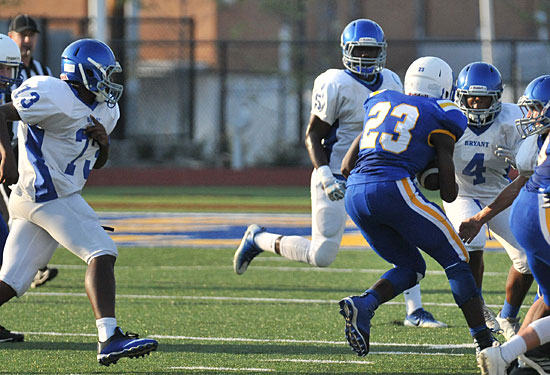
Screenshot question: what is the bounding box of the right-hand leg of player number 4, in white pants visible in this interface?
[489,209,533,340]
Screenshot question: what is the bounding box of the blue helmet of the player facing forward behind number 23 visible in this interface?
[340,19,388,77]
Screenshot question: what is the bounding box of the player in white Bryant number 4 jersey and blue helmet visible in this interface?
[443,62,533,338]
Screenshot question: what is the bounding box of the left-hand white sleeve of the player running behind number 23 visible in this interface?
[311,73,339,124]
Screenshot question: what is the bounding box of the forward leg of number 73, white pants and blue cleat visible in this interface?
[29,194,158,366]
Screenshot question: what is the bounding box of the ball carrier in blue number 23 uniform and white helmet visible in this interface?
[340,57,496,356]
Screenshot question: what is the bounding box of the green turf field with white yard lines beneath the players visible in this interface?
[0,188,534,375]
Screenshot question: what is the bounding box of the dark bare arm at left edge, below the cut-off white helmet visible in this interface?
[0,103,21,184]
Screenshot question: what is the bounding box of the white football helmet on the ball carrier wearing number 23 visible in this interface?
[405,56,454,100]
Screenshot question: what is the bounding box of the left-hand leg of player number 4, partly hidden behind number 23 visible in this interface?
[443,197,500,332]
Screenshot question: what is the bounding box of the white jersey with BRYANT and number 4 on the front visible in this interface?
[453,103,522,198]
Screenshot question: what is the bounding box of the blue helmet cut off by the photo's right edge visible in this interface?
[516,75,550,138]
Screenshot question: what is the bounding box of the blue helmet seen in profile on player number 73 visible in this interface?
[61,39,123,107]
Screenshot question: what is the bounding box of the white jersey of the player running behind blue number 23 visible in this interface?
[311,69,403,175]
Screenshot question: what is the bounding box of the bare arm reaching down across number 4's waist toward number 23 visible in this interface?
[458,175,529,244]
